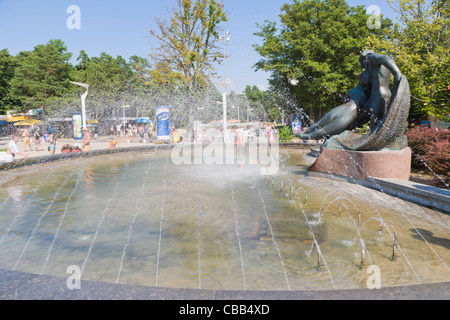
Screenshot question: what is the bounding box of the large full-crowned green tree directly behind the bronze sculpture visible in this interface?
[254,0,390,118]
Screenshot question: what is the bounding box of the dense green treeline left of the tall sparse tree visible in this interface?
[0,40,156,117]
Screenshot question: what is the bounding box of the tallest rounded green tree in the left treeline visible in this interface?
[10,40,72,111]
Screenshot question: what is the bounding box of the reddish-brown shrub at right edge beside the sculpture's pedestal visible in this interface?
[406,127,450,182]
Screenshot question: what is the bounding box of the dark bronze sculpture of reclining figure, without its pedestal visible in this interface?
[297,50,410,151]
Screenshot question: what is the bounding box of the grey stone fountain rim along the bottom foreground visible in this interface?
[0,269,450,300]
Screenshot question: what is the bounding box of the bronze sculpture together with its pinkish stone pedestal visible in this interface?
[297,50,411,180]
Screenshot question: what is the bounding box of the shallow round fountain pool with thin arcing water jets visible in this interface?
[0,67,450,299]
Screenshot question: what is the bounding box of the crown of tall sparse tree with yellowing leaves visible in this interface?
[150,0,227,92]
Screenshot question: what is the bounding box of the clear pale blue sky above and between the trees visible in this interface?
[0,0,395,93]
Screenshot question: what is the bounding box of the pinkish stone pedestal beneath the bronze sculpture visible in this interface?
[308,148,411,180]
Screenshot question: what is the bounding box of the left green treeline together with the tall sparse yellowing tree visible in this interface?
[0,0,230,121]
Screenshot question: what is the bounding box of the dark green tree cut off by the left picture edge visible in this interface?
[0,49,16,114]
